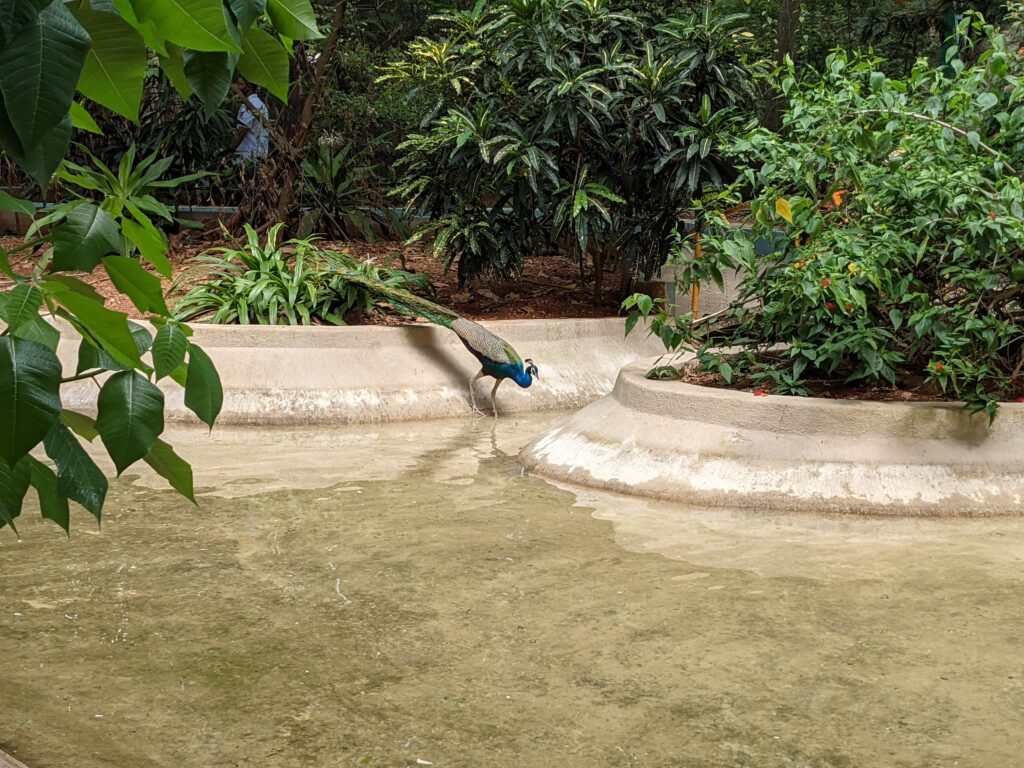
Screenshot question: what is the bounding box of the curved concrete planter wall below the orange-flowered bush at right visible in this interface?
[519,364,1024,515]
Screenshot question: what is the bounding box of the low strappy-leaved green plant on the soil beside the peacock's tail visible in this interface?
[175,224,430,326]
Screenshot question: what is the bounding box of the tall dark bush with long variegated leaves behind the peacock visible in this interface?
[384,0,751,291]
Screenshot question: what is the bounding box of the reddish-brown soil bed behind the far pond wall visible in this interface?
[0,233,620,325]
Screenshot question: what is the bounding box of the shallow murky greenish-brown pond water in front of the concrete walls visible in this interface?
[0,416,1024,768]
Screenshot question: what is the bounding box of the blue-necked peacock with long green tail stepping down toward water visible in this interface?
[344,271,541,419]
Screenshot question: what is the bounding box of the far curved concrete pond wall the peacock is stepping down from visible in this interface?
[60,317,658,425]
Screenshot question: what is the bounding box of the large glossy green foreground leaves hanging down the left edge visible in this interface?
[0,0,318,529]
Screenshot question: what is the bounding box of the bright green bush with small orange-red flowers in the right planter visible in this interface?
[631,16,1024,418]
